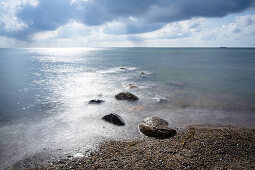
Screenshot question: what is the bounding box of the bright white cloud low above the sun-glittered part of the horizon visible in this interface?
[28,21,129,47]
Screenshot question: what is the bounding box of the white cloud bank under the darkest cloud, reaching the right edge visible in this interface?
[137,14,255,47]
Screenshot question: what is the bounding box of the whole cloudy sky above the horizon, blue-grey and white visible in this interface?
[0,0,255,47]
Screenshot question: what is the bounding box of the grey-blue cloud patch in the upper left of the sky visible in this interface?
[0,0,77,40]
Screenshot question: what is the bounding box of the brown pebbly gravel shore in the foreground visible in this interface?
[13,125,255,169]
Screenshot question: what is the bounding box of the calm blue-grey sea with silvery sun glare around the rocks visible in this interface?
[0,48,255,167]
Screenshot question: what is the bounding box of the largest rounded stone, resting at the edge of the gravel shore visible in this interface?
[139,116,176,138]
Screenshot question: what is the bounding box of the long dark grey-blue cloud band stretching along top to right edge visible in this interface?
[78,0,255,25]
